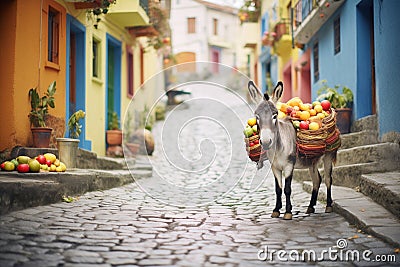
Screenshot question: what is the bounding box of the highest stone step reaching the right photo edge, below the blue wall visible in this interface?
[336,143,400,166]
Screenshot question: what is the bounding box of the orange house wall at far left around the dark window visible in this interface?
[0,0,65,152]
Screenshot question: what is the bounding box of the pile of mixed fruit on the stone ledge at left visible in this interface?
[0,153,67,173]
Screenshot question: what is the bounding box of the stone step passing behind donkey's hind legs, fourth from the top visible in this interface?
[293,162,399,188]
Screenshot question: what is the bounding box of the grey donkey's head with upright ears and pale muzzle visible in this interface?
[248,81,283,150]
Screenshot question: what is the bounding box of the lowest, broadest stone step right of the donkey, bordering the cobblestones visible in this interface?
[303,182,400,247]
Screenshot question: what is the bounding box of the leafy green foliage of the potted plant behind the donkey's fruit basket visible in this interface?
[317,80,353,108]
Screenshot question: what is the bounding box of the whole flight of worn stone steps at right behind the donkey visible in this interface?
[293,116,400,247]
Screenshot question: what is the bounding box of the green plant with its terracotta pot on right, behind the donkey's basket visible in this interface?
[317,80,353,133]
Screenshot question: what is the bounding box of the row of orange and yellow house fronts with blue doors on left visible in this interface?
[0,0,166,158]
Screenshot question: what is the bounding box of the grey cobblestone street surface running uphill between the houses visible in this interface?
[0,80,399,267]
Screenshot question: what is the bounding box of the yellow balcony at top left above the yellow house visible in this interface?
[107,0,150,27]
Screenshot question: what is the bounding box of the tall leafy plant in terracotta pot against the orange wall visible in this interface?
[28,81,56,148]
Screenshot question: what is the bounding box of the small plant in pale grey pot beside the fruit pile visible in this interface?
[56,110,85,169]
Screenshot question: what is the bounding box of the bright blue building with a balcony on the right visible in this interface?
[293,0,400,141]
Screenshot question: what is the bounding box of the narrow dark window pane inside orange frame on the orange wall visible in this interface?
[47,6,60,64]
